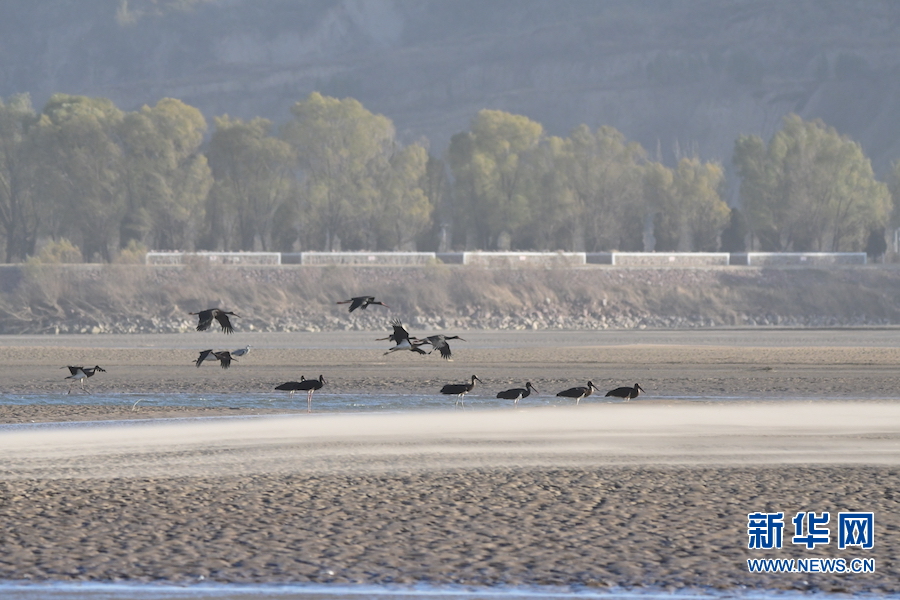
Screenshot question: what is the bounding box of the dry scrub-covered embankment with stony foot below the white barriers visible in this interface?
[0,265,900,334]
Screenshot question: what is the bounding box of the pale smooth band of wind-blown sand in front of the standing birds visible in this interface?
[0,403,900,479]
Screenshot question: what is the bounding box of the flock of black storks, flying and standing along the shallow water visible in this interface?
[62,296,646,413]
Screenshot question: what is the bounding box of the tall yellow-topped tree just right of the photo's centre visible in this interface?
[449,110,543,248]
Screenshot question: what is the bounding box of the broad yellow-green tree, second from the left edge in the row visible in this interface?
[35,94,127,261]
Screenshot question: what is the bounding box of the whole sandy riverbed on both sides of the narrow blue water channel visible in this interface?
[0,333,900,593]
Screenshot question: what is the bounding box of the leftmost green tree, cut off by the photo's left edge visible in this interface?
[0,95,39,262]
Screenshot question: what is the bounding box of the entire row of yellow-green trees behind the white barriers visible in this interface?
[0,93,900,262]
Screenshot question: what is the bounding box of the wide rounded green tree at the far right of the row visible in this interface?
[734,115,891,251]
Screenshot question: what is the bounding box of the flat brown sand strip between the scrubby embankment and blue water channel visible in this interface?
[0,329,900,409]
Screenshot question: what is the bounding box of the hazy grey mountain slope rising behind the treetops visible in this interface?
[0,0,900,174]
